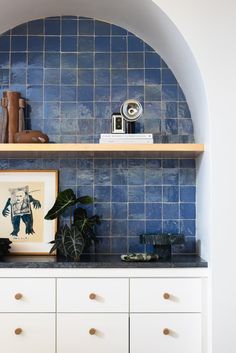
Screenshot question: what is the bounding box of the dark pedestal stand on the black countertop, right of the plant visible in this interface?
[140,233,185,260]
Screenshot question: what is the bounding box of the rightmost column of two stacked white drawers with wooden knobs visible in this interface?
[130,278,202,353]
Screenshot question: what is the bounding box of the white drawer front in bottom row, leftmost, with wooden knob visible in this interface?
[0,314,55,353]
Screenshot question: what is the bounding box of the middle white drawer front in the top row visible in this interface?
[57,278,129,312]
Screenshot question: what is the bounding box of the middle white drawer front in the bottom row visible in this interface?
[57,313,129,353]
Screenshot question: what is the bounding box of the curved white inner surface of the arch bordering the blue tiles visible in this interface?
[0,0,210,257]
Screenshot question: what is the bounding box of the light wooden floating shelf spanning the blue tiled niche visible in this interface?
[0,143,204,157]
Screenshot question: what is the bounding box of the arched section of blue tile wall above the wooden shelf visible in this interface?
[0,17,193,142]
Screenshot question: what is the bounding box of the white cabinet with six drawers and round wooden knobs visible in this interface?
[0,268,207,353]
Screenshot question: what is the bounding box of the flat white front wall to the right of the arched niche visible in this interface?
[153,4,236,353]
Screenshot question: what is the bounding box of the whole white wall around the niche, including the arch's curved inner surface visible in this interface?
[0,0,236,353]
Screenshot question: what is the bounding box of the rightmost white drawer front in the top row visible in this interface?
[130,278,202,312]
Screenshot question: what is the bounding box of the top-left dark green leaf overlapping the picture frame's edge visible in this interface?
[44,189,78,220]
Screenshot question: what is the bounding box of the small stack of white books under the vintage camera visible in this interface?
[99,134,153,144]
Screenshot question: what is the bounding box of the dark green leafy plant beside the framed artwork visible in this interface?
[44,189,101,261]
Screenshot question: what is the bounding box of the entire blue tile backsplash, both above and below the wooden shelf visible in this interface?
[0,16,196,253]
